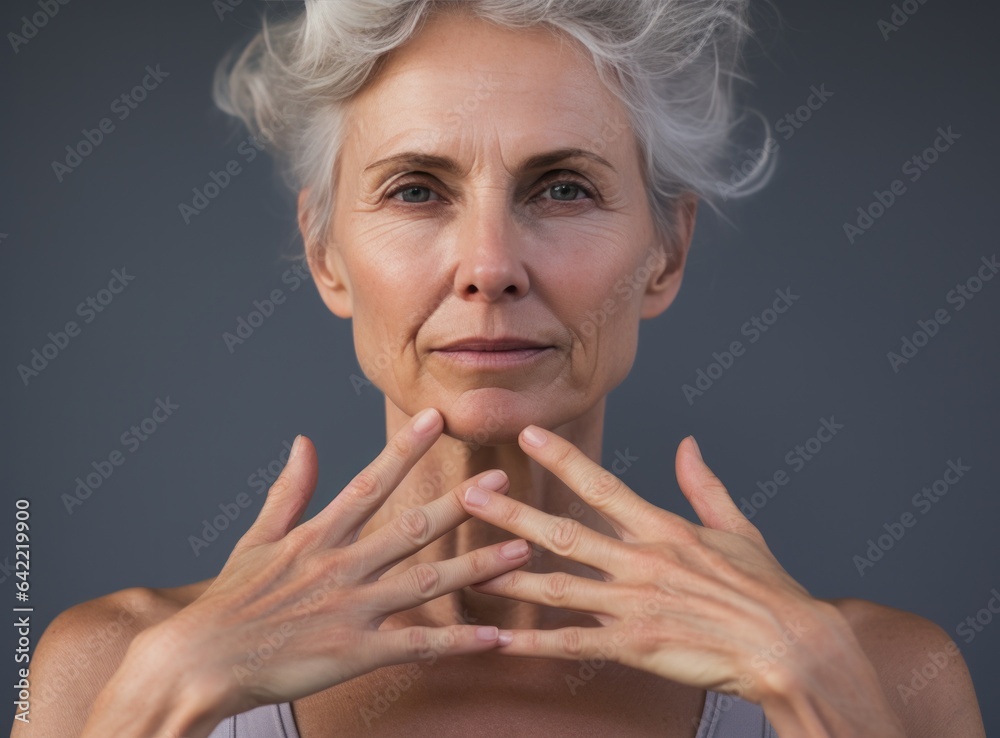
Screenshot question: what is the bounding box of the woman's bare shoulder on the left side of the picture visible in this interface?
[11,580,217,738]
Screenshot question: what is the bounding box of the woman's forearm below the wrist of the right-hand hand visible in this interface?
[761,608,906,738]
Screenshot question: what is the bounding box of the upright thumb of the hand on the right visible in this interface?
[675,436,763,540]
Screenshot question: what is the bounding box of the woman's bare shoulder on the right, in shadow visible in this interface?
[824,597,986,738]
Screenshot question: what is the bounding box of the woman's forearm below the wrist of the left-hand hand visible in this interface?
[80,620,232,738]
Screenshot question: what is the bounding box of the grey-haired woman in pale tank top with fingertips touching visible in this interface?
[14,0,984,738]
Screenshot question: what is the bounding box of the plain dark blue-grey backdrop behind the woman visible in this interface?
[0,0,1000,735]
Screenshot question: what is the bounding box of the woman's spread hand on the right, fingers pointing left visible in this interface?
[463,426,849,702]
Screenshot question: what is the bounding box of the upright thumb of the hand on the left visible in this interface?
[240,435,319,545]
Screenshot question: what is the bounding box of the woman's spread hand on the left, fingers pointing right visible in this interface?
[144,410,530,717]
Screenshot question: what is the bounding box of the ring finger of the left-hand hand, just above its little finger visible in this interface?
[365,539,531,613]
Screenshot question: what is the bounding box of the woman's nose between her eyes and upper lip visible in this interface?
[455,196,529,302]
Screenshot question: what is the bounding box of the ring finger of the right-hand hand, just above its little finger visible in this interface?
[471,569,618,615]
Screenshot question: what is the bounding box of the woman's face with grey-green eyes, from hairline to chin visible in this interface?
[313,8,693,443]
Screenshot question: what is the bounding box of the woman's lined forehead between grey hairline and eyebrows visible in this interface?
[347,11,626,162]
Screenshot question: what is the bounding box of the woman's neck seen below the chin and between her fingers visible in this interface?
[360,398,615,628]
